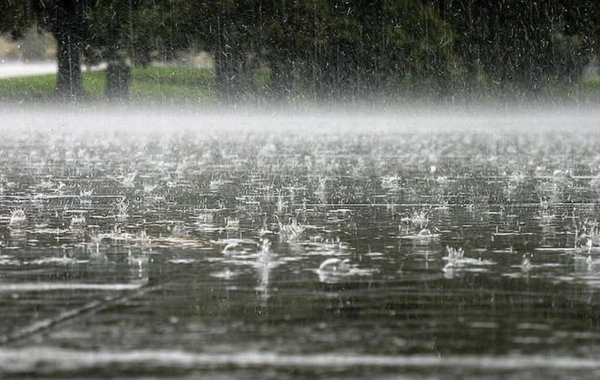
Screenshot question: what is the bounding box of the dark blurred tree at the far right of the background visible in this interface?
[444,0,600,95]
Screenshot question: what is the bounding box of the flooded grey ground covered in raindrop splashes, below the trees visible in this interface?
[0,110,600,379]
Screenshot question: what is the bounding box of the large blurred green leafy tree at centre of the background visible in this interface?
[227,0,452,100]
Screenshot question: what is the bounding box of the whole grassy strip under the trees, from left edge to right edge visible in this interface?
[0,66,600,106]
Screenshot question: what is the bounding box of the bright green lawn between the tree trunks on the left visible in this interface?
[0,66,217,102]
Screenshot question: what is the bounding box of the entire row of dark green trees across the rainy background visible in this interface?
[0,0,600,101]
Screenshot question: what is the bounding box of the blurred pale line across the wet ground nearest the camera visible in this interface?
[0,347,600,374]
